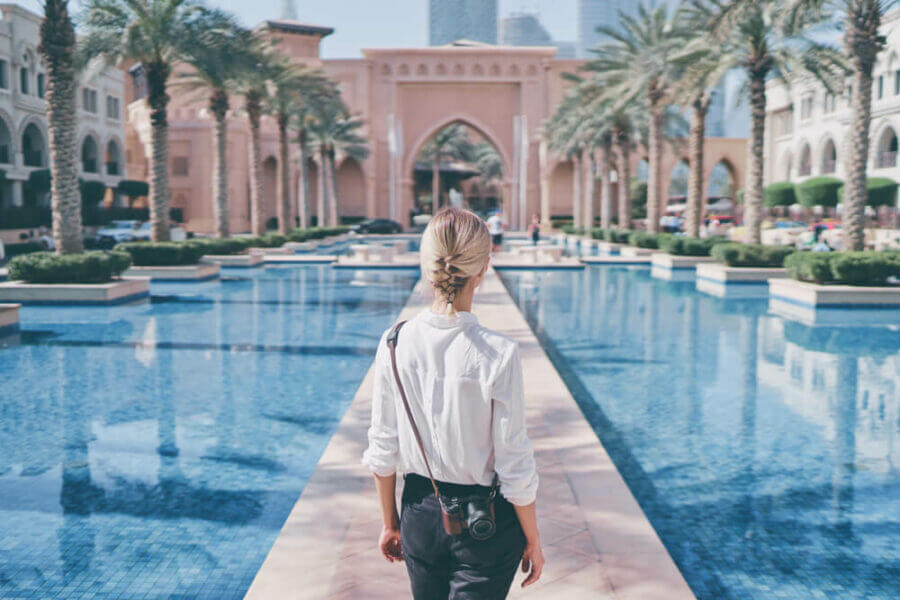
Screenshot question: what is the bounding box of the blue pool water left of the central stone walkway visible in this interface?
[0,266,417,600]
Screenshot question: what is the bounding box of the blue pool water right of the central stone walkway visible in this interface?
[502,266,900,600]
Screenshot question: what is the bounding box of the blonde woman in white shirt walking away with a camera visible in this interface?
[363,208,544,600]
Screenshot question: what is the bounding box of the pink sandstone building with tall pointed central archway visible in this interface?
[127,20,746,233]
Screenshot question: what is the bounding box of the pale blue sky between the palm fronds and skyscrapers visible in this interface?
[16,0,575,58]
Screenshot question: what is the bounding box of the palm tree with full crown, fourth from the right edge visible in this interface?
[586,3,688,232]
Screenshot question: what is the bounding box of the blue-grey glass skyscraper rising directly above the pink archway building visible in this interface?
[428,0,497,46]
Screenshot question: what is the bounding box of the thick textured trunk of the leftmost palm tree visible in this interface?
[40,0,84,254]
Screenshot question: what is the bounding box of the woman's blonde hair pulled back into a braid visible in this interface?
[419,207,491,315]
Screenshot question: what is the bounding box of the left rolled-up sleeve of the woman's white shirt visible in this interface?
[362,334,400,477]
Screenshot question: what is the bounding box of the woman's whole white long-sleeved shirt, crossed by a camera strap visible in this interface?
[363,310,538,506]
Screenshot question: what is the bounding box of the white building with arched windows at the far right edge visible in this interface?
[764,11,900,184]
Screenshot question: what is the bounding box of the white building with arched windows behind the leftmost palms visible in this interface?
[0,4,125,212]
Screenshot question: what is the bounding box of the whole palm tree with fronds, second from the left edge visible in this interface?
[81,0,201,241]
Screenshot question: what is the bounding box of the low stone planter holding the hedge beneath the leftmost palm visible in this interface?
[0,277,150,306]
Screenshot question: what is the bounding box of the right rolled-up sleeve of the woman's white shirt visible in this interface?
[492,345,538,506]
